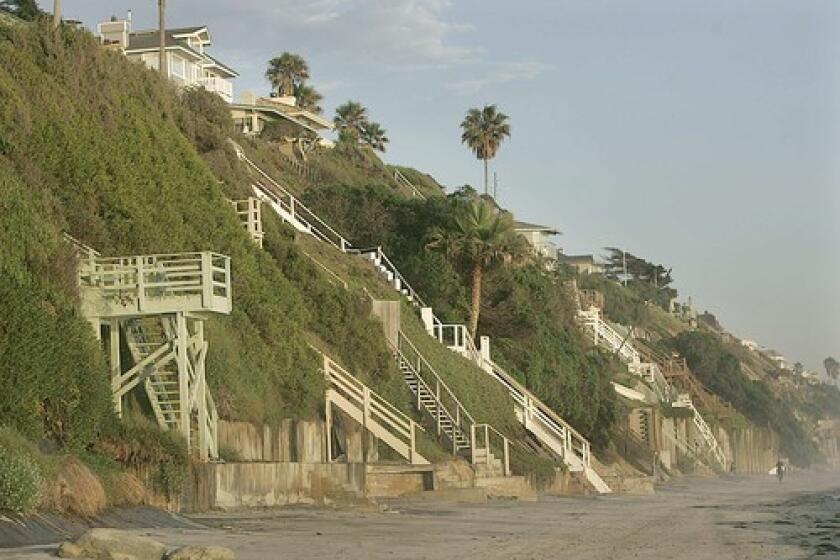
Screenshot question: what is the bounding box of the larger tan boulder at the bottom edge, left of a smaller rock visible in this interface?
[58,529,166,560]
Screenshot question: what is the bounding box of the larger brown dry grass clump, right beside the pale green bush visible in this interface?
[41,456,108,518]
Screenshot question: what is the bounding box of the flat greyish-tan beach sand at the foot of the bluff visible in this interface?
[0,473,840,560]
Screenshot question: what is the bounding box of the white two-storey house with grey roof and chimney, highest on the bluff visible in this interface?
[97,16,239,103]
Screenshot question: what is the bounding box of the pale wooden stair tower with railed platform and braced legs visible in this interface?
[74,246,226,460]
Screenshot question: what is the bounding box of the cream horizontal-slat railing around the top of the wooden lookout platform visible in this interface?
[79,251,231,313]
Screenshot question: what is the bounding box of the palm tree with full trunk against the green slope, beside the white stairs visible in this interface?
[428,199,522,337]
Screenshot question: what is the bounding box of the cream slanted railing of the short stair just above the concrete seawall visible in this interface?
[323,356,428,465]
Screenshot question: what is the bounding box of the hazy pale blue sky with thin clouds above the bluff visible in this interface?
[69,0,840,371]
